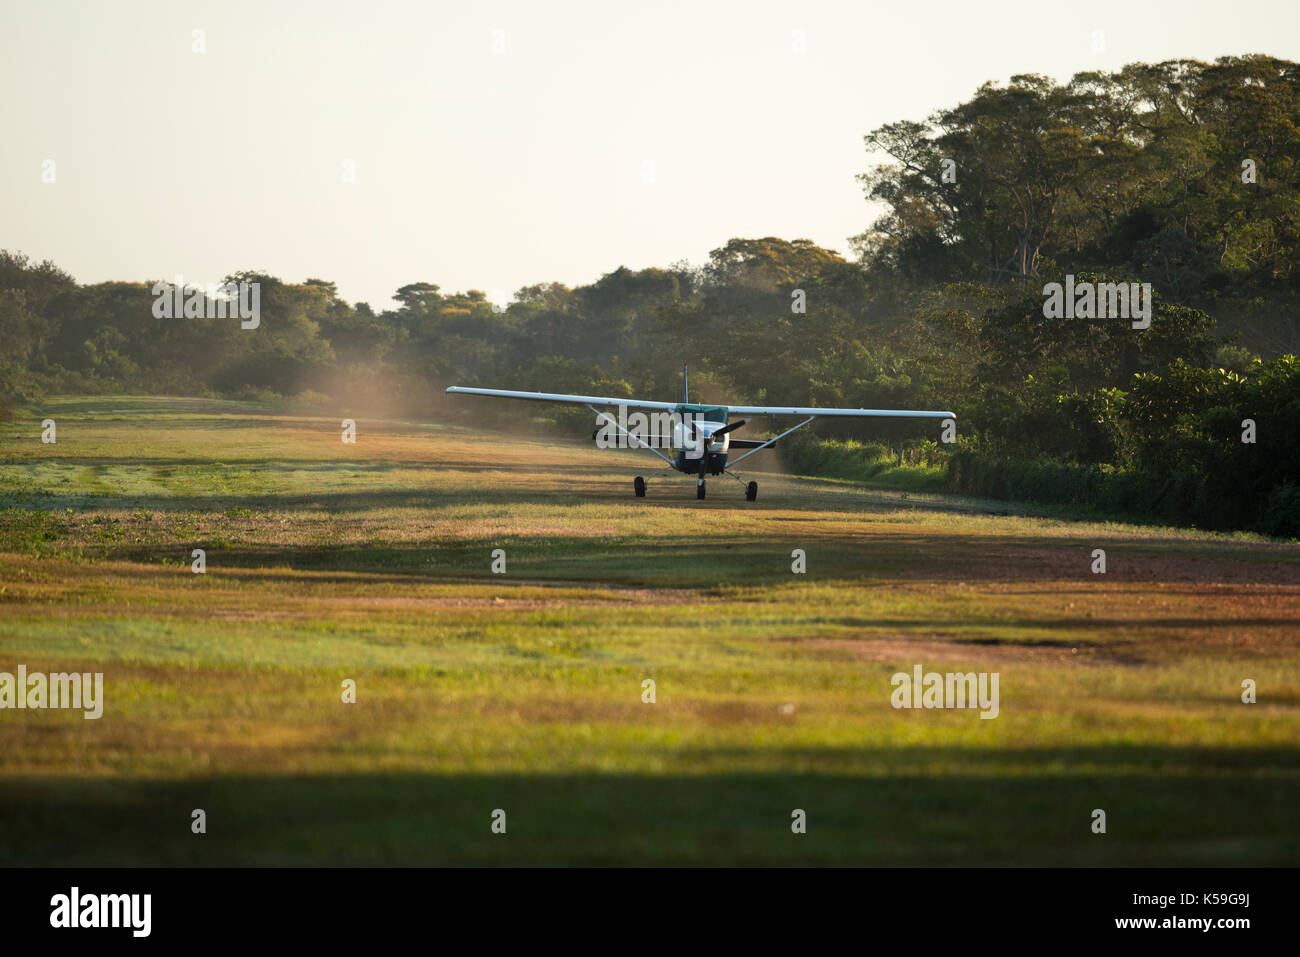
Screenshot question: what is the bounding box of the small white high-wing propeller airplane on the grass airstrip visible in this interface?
[447,365,957,502]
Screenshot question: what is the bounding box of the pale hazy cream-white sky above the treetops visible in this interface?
[0,0,1300,307]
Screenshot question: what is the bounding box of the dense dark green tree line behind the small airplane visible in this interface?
[0,56,1300,536]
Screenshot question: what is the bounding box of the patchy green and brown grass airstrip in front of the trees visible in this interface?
[0,397,1300,865]
